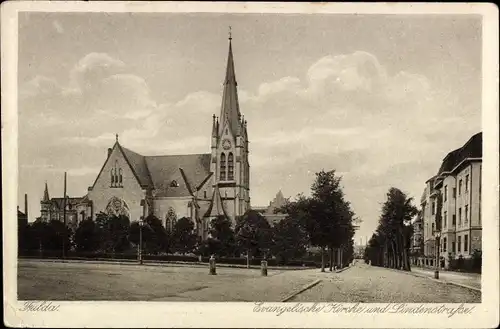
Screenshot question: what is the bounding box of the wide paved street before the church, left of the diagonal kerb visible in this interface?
[18,259,316,302]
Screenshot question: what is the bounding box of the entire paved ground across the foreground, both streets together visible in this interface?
[18,260,481,303]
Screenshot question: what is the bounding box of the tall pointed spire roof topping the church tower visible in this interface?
[219,30,240,136]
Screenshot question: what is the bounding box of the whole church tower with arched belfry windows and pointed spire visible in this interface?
[211,32,250,221]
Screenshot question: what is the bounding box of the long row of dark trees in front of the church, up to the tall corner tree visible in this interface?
[19,171,358,270]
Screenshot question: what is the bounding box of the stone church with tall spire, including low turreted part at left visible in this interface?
[41,36,250,239]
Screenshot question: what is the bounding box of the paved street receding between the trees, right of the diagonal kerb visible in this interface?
[291,263,481,303]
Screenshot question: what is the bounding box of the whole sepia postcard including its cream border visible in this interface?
[2,3,499,327]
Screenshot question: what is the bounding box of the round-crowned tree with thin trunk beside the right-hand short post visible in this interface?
[235,210,271,266]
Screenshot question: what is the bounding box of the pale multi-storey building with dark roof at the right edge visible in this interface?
[422,133,482,267]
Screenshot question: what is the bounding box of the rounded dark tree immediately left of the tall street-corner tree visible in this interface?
[271,217,308,264]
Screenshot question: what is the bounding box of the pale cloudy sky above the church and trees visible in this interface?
[18,12,482,243]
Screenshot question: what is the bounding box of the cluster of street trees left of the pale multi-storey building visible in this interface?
[364,188,418,271]
